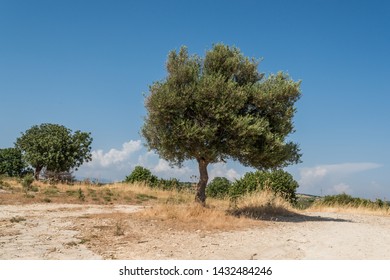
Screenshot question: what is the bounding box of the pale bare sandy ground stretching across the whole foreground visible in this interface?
[0,204,390,260]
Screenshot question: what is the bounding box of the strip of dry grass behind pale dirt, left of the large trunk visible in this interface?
[0,179,190,205]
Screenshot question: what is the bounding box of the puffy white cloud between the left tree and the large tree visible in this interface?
[90,140,142,167]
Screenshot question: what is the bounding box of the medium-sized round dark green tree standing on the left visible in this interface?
[15,123,92,179]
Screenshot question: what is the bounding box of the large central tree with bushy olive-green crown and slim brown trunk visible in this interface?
[142,44,301,204]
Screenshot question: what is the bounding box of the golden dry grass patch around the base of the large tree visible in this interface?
[134,188,296,231]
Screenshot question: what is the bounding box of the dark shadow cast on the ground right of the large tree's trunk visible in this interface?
[228,205,353,223]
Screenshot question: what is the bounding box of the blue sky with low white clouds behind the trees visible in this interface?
[0,0,390,199]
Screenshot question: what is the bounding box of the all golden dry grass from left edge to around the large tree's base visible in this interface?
[0,178,291,231]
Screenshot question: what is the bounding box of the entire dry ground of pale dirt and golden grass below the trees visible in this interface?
[0,178,390,260]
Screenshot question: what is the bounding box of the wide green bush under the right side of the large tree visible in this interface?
[229,169,299,203]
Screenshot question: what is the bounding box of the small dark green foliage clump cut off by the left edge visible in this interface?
[0,148,27,177]
